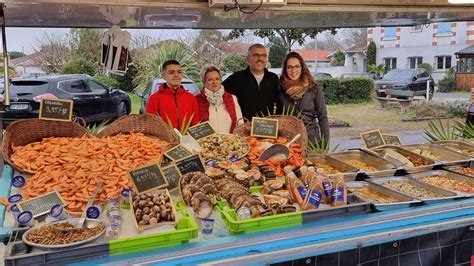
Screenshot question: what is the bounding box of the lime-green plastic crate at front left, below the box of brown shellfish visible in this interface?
[109,208,198,256]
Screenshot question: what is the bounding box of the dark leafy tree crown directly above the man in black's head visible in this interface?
[228,28,336,51]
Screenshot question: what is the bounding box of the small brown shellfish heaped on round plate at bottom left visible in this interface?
[26,222,104,245]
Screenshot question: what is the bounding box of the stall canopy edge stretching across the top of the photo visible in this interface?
[0,0,474,29]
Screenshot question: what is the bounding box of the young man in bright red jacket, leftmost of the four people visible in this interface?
[146,60,199,130]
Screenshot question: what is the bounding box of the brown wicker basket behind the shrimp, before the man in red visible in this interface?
[97,114,179,144]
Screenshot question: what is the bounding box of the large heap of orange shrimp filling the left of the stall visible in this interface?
[11,132,168,215]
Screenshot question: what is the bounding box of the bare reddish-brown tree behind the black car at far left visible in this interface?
[34,32,70,73]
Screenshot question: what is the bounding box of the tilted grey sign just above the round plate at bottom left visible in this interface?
[17,191,64,217]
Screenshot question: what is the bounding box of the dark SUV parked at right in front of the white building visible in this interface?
[375,68,434,99]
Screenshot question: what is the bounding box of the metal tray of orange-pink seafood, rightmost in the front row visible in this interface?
[408,170,474,197]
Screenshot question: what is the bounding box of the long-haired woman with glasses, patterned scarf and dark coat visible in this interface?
[279,52,329,144]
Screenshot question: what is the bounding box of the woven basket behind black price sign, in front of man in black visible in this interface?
[234,115,308,159]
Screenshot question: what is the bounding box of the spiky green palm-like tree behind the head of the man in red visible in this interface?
[133,40,200,89]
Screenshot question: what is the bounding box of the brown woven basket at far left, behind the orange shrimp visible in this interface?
[2,118,88,170]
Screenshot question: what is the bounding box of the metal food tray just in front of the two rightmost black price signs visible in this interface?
[373,145,440,173]
